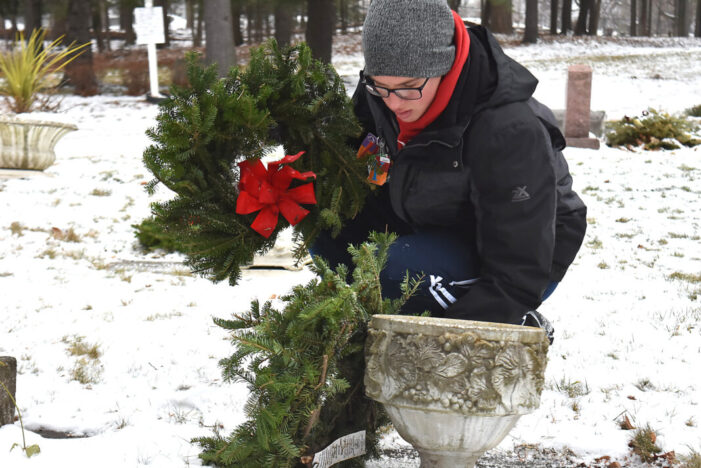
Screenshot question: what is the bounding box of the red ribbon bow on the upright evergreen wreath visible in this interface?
[236,151,316,239]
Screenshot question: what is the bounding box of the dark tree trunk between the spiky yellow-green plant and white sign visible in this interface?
[64,0,97,96]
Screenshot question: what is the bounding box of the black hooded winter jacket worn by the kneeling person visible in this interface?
[353,27,586,323]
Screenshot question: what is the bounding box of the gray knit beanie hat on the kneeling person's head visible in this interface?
[363,0,455,78]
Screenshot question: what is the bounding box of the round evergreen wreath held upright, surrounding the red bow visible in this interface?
[144,41,371,286]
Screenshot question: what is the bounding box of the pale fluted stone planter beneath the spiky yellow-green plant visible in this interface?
[0,117,78,171]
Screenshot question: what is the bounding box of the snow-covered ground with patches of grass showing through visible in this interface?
[0,33,701,468]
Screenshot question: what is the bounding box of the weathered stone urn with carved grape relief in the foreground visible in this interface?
[365,315,548,468]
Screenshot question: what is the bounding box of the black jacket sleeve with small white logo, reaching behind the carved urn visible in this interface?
[446,104,557,323]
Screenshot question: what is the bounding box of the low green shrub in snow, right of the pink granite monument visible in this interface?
[606,109,701,150]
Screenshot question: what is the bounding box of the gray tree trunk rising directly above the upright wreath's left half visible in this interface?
[204,0,236,76]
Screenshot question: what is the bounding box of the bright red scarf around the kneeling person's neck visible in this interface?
[397,11,470,149]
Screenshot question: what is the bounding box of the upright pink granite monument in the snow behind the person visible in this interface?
[565,65,599,149]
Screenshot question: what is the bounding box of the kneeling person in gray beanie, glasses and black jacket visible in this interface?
[311,0,586,340]
